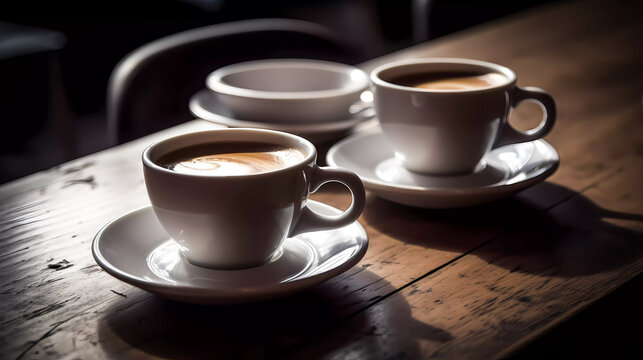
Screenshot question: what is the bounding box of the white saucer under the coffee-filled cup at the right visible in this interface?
[327,131,560,208]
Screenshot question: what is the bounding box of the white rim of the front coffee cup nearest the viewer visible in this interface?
[142,128,317,179]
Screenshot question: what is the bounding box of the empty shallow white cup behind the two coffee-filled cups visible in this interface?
[206,59,369,123]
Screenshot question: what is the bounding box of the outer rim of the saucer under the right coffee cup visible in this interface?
[326,129,560,197]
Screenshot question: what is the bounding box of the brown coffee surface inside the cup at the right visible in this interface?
[391,72,507,90]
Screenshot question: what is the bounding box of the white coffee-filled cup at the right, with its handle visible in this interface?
[371,58,556,175]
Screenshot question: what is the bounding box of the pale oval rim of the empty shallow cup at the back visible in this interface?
[206,59,369,100]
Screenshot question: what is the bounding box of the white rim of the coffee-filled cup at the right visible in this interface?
[370,57,517,94]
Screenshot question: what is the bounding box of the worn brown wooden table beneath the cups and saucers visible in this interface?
[0,1,643,359]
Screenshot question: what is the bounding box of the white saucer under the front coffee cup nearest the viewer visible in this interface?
[92,200,368,304]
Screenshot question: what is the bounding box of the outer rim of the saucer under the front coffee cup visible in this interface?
[92,199,369,303]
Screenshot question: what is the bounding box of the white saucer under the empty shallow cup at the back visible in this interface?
[189,89,375,142]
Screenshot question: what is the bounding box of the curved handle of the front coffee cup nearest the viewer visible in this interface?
[288,165,366,237]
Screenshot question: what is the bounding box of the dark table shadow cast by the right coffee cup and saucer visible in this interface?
[364,183,643,277]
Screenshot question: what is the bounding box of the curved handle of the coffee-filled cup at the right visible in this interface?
[493,87,556,148]
